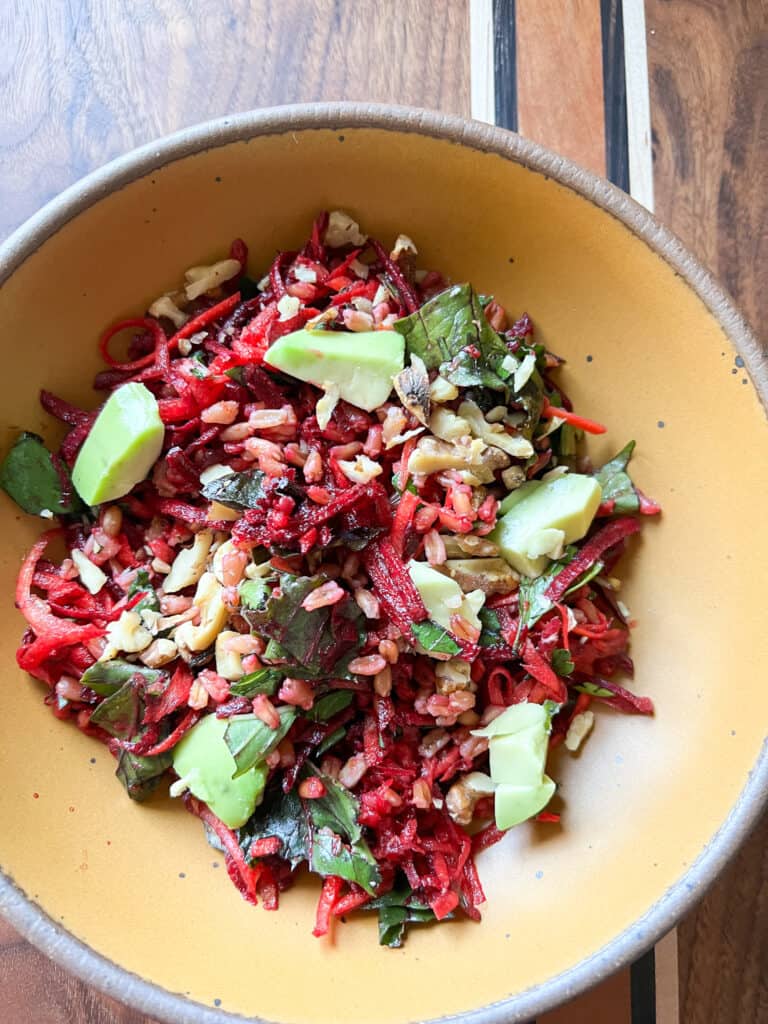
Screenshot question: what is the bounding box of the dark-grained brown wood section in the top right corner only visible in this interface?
[646,0,768,332]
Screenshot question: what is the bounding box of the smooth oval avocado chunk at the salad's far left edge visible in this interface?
[72,384,165,505]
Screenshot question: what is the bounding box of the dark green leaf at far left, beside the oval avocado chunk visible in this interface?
[0,431,83,515]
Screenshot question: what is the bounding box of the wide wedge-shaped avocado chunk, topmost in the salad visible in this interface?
[265,328,406,413]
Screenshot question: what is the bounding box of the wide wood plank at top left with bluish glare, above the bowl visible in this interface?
[0,0,469,238]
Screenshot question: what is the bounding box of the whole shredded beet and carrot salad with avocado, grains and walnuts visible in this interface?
[0,211,658,946]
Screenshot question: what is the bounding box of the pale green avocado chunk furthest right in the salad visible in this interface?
[488,473,602,577]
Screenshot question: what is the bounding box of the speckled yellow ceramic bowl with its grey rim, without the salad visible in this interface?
[0,105,768,1024]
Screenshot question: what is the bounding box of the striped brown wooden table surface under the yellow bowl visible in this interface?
[0,0,768,1024]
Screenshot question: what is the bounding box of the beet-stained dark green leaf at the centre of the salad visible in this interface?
[246,575,365,679]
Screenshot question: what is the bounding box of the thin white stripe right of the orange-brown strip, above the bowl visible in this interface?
[622,0,653,211]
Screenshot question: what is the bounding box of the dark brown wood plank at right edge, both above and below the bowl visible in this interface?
[646,0,768,1024]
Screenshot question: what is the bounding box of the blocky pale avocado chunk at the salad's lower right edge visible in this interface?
[472,701,557,830]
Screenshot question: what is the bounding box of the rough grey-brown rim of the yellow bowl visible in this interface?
[0,102,768,1024]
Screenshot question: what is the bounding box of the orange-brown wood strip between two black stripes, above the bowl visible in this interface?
[515,0,605,174]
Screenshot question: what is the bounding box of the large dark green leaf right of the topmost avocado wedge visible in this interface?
[394,285,510,391]
